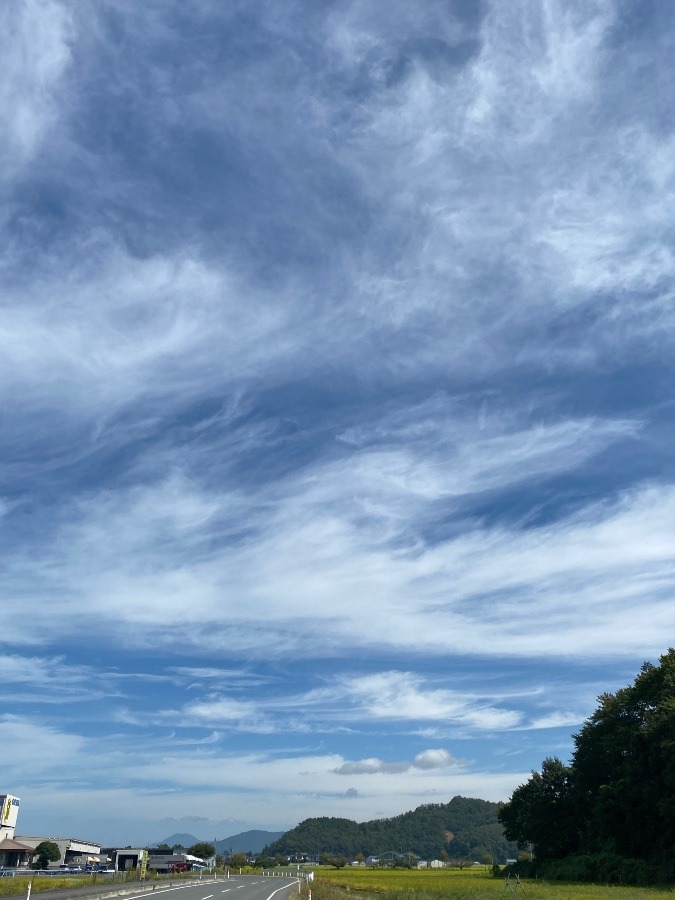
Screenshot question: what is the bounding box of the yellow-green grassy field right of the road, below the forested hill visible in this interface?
[309,867,675,900]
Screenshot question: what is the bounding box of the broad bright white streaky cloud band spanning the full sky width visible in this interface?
[5,408,675,660]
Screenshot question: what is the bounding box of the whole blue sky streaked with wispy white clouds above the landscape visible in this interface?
[0,0,675,844]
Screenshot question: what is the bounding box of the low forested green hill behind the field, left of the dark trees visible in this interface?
[265,797,516,862]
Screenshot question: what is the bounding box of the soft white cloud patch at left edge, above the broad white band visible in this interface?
[0,251,284,416]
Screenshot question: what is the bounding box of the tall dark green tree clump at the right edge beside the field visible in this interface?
[498,648,675,884]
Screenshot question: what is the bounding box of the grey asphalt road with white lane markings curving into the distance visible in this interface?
[31,875,298,900]
